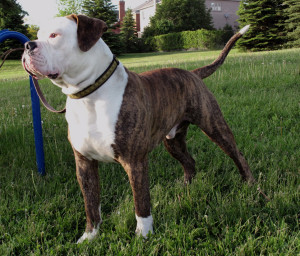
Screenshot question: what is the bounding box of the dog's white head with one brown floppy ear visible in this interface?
[22,14,107,81]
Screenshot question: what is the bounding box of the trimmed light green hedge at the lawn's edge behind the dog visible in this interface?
[152,29,224,51]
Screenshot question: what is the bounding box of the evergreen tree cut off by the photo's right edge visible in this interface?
[284,0,300,47]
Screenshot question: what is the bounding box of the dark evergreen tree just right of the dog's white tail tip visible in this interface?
[237,0,286,51]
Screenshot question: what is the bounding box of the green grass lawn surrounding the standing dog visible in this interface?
[0,49,300,255]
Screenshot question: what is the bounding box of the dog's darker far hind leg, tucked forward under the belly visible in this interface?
[164,122,196,183]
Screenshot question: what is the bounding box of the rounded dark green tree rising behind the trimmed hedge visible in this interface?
[145,0,212,36]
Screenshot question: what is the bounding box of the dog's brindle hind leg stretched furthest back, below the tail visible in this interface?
[198,98,255,183]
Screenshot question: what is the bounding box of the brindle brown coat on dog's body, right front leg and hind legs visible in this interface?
[112,68,254,217]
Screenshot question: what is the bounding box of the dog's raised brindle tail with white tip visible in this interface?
[192,25,250,79]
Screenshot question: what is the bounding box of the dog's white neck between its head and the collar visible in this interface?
[51,39,113,95]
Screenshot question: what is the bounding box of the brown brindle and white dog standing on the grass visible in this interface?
[22,14,255,243]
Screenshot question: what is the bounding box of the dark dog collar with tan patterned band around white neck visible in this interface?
[68,56,120,99]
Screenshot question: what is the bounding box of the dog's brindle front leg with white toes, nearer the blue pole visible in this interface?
[73,149,102,243]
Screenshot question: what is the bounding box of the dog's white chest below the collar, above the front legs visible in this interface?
[66,69,127,162]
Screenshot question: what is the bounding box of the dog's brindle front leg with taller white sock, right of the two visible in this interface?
[122,160,153,238]
